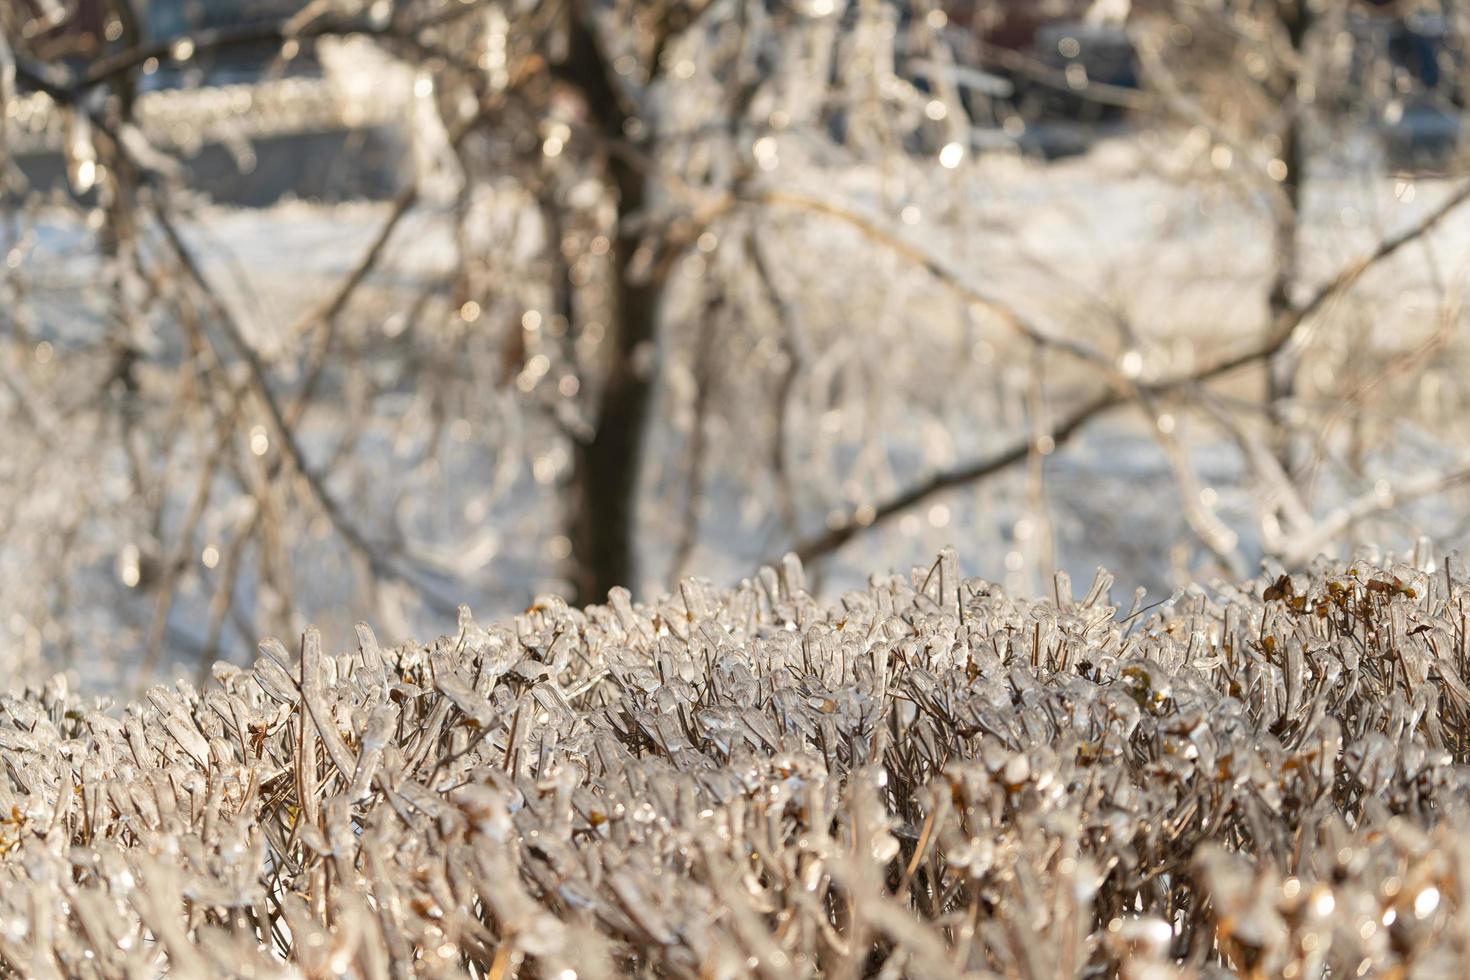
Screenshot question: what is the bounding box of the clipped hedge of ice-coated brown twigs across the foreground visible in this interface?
[0,554,1470,980]
